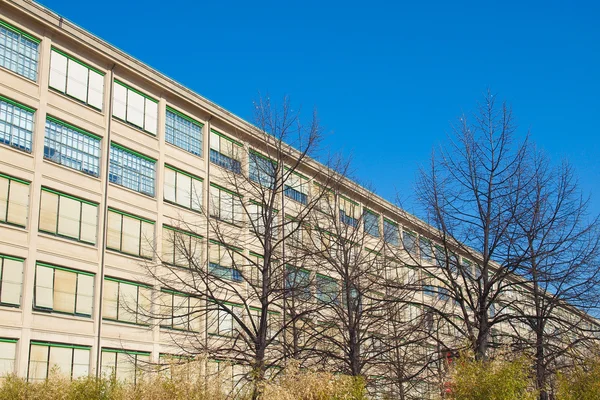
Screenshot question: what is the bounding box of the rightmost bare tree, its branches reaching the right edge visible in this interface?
[504,151,600,400]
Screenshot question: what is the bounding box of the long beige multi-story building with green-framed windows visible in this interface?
[0,0,596,396]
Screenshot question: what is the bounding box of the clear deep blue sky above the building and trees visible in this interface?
[42,0,600,219]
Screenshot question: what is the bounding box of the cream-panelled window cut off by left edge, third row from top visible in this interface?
[0,174,29,228]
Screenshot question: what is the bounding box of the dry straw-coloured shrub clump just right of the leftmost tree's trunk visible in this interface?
[261,363,366,400]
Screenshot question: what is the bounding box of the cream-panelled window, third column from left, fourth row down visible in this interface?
[102,277,152,325]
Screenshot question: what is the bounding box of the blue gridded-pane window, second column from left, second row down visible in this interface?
[44,117,101,177]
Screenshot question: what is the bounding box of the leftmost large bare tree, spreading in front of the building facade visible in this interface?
[142,98,343,398]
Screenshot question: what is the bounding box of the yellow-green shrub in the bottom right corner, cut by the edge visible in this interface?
[556,359,600,400]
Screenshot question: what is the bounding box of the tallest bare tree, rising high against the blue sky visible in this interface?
[417,93,529,359]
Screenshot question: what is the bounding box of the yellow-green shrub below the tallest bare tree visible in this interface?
[448,354,538,400]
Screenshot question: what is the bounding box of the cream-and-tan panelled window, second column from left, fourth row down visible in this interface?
[33,262,94,317]
